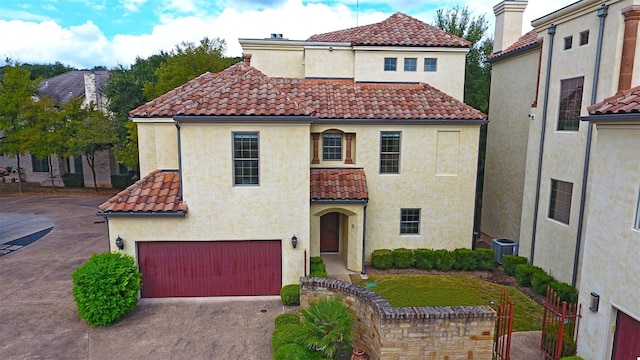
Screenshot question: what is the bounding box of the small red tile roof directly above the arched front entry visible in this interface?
[310,168,369,201]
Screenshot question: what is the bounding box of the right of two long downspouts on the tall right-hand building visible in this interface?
[571,4,609,287]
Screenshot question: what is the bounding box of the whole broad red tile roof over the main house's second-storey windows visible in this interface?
[129,63,486,120]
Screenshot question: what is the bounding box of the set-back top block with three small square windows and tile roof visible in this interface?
[239,12,471,100]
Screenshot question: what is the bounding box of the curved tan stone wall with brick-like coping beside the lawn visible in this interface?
[300,277,496,360]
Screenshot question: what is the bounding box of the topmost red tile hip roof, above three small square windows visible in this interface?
[307,12,471,47]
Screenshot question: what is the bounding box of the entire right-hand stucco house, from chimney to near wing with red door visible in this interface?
[482,0,640,359]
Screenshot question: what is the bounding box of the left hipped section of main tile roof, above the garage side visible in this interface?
[129,62,313,117]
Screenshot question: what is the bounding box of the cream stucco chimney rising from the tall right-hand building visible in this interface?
[493,0,528,53]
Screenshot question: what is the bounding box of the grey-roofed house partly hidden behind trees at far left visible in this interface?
[0,70,127,187]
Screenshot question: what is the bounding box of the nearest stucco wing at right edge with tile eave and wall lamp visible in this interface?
[578,87,640,360]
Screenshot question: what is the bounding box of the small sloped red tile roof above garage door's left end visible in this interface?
[98,170,187,216]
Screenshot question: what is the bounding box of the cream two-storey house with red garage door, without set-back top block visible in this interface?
[98,12,486,297]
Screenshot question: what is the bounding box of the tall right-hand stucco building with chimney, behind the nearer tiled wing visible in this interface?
[482,0,640,288]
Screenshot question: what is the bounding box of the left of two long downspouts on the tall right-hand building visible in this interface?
[529,24,556,264]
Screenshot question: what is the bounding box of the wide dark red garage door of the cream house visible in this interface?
[138,240,282,298]
